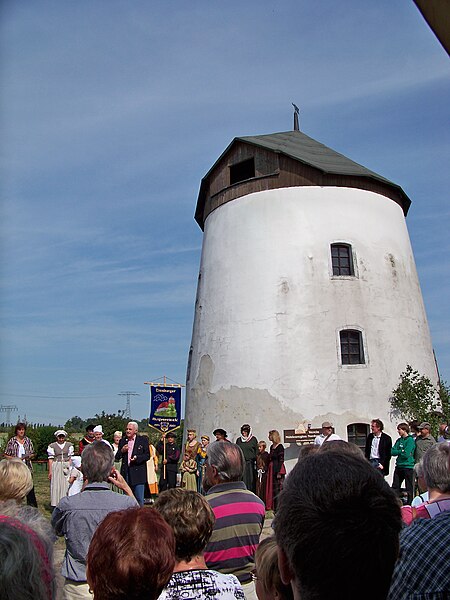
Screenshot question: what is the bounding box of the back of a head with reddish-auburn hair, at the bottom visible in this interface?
[86,508,175,600]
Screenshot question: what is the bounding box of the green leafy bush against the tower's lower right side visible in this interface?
[390,365,442,432]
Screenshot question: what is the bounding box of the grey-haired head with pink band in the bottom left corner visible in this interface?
[0,501,56,600]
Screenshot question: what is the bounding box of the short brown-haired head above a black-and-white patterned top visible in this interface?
[154,488,215,562]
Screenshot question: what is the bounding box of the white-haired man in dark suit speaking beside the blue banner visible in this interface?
[116,421,150,506]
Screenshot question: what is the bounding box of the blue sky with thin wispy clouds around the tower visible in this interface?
[0,0,450,424]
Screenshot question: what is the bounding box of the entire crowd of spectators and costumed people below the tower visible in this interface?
[0,419,450,600]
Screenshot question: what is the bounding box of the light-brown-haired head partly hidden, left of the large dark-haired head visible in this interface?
[255,536,293,600]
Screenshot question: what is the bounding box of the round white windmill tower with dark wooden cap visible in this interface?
[186,126,437,458]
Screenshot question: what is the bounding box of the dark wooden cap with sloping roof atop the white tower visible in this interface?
[195,131,411,230]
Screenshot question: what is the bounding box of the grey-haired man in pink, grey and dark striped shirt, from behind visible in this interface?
[203,442,265,599]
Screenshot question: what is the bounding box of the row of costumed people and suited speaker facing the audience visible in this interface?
[37,421,286,510]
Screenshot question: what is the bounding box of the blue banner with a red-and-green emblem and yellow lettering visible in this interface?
[148,385,181,432]
